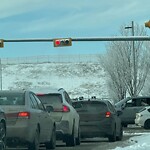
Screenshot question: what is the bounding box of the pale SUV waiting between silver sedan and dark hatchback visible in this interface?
[32,88,80,146]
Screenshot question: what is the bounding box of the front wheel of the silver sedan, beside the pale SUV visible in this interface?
[45,127,56,150]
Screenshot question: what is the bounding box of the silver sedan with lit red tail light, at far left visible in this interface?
[0,90,56,150]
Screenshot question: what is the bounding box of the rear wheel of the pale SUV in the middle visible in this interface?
[66,127,76,146]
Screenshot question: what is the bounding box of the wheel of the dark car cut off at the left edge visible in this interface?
[0,122,6,150]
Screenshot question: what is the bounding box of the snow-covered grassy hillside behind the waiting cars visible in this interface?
[2,63,109,98]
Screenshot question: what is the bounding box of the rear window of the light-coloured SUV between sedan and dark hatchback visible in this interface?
[37,94,62,105]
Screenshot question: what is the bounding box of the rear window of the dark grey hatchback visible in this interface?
[74,102,107,113]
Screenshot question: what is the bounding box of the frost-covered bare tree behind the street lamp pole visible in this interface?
[101,24,150,99]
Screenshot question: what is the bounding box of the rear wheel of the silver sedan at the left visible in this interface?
[28,129,40,150]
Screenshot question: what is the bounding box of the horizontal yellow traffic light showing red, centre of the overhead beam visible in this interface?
[53,38,72,47]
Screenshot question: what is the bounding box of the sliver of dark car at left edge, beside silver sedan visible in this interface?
[0,108,6,150]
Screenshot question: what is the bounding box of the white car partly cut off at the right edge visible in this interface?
[135,106,150,129]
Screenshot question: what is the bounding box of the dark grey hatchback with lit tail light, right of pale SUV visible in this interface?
[73,99,123,142]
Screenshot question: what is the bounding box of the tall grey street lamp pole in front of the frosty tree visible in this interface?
[125,21,137,96]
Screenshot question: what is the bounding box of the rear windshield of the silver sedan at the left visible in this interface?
[0,93,25,105]
